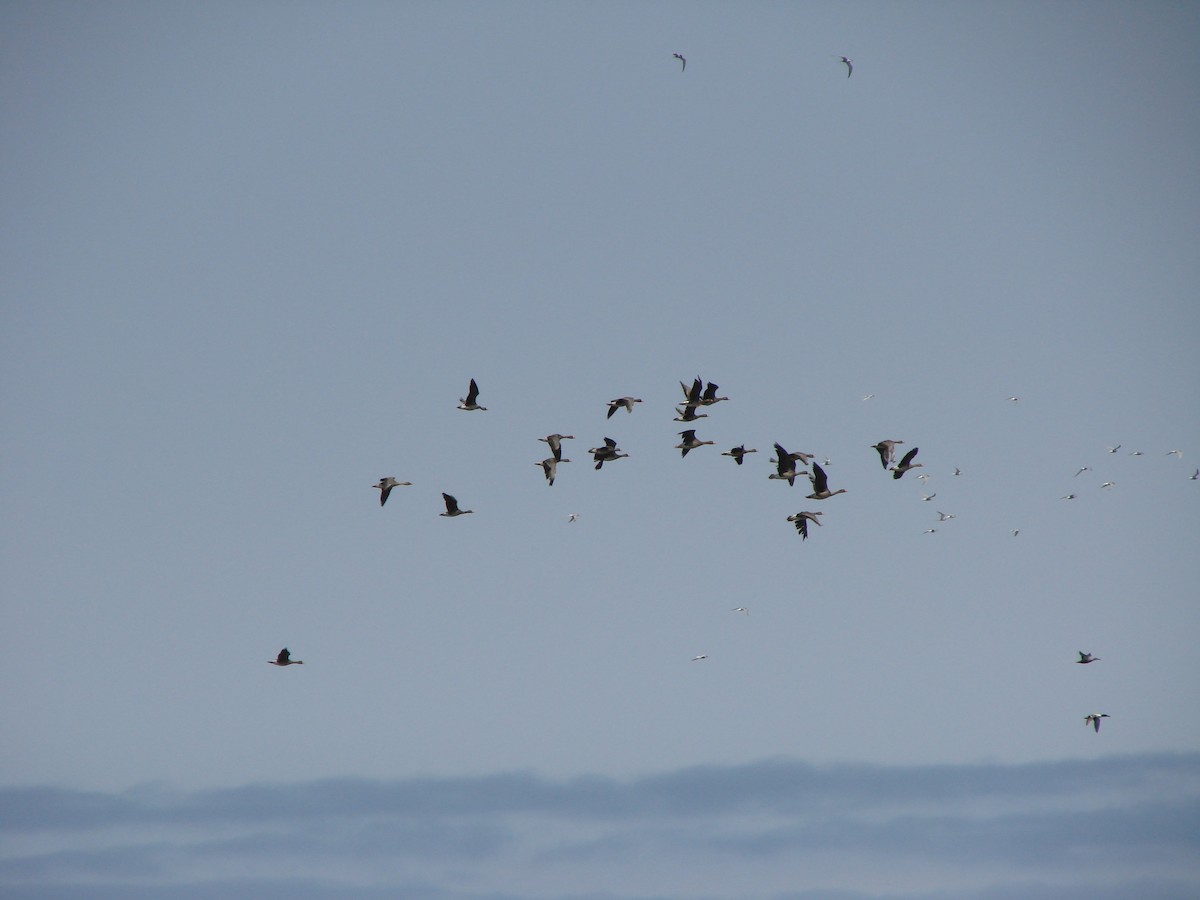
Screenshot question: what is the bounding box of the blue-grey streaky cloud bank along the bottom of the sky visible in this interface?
[0,755,1200,900]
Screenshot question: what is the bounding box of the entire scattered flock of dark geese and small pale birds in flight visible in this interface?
[268,374,1200,733]
